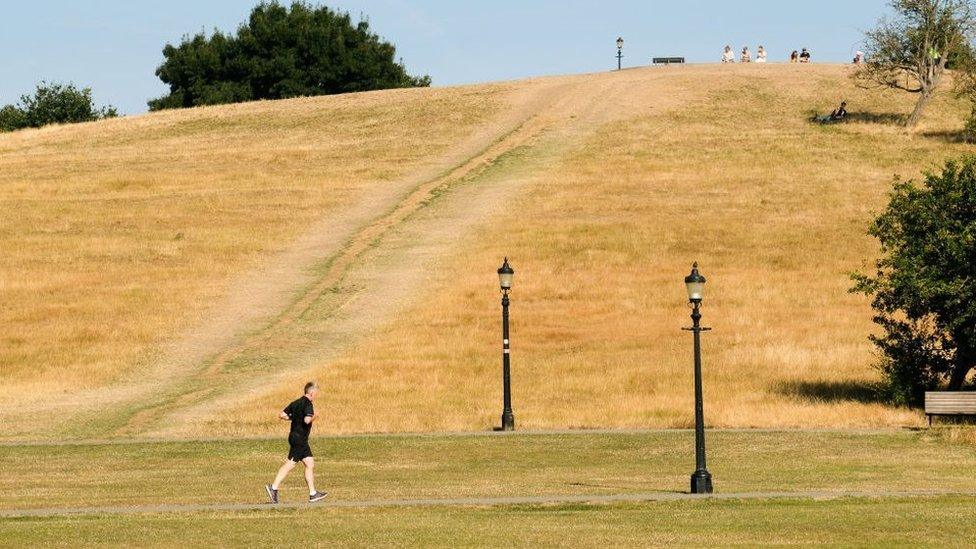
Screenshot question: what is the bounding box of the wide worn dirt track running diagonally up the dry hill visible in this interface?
[0,70,700,437]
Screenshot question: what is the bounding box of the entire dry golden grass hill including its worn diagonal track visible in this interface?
[0,64,968,439]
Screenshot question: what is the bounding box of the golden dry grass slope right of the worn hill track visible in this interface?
[227,66,967,431]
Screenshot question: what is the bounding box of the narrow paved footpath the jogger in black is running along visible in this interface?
[0,491,976,518]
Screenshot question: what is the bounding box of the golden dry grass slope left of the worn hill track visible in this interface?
[0,86,503,392]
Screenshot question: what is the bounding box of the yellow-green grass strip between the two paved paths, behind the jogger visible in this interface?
[0,430,976,509]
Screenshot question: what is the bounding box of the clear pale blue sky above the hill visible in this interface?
[0,0,886,113]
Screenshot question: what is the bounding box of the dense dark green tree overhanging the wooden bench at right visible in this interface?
[853,157,976,404]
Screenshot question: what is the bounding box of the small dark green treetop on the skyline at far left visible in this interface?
[0,82,118,131]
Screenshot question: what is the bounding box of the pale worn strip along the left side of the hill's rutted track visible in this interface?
[0,79,566,436]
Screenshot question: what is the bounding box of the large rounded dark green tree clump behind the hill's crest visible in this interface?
[149,2,430,110]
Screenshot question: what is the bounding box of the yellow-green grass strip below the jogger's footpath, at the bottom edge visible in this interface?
[0,497,976,547]
